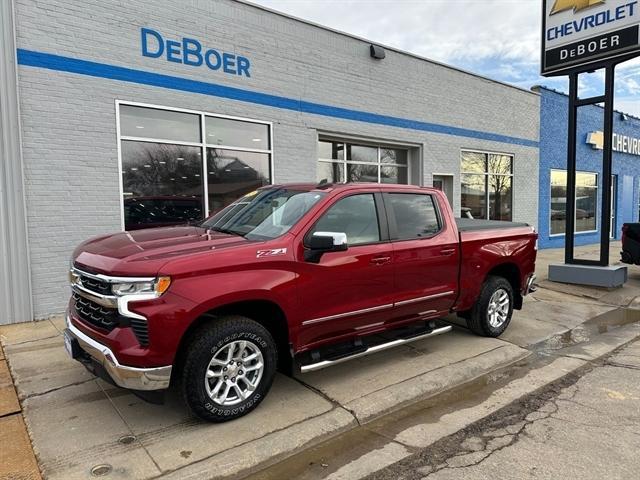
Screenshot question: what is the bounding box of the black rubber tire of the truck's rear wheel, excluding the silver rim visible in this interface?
[466,276,513,337]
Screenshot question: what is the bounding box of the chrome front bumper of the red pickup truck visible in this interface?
[67,315,171,390]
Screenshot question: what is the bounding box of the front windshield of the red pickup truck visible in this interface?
[202,188,325,240]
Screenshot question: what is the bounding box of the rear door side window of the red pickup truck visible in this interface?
[386,193,442,240]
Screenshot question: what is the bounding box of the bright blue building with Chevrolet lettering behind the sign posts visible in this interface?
[533,87,640,249]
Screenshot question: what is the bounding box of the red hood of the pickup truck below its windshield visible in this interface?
[73,226,249,276]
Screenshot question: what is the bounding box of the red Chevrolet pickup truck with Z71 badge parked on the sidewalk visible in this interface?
[65,184,537,421]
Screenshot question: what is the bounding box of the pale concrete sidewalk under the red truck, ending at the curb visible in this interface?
[0,244,640,480]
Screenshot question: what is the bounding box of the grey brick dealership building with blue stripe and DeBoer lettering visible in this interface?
[0,0,540,323]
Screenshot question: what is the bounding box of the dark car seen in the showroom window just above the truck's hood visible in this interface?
[124,196,202,230]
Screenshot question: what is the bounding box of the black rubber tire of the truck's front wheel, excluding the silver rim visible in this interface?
[181,315,278,422]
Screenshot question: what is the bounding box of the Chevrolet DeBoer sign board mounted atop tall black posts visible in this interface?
[542,0,640,75]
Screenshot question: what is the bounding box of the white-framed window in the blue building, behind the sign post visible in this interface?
[549,170,598,235]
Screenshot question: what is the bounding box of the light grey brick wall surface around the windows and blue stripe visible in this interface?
[15,0,539,317]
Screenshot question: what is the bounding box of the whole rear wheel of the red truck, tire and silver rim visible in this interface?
[467,276,513,337]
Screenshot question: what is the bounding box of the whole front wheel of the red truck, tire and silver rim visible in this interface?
[182,316,278,422]
